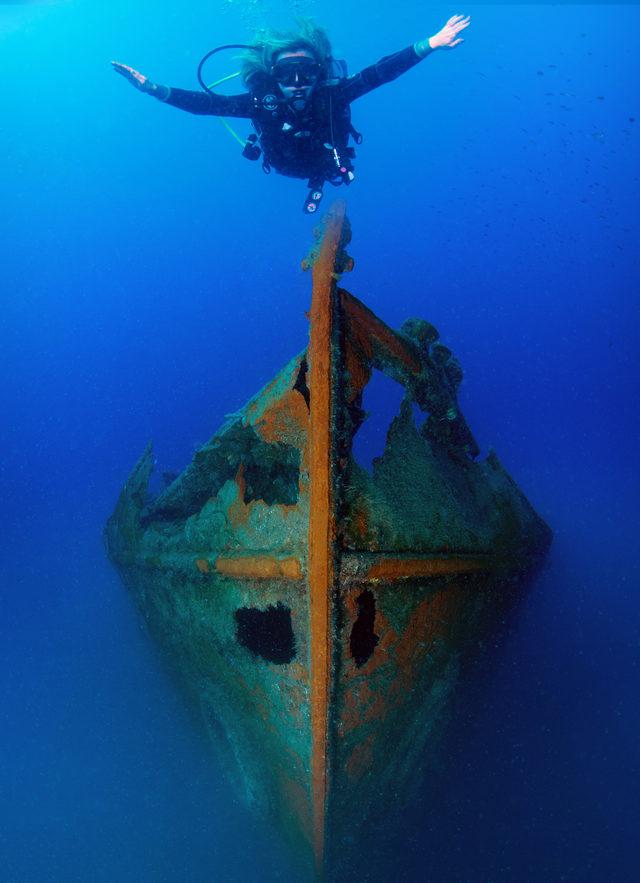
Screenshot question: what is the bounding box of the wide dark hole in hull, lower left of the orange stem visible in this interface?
[235,603,296,665]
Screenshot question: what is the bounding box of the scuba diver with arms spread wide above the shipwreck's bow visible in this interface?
[112,15,471,214]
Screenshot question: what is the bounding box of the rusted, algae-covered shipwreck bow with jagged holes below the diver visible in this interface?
[106,204,551,877]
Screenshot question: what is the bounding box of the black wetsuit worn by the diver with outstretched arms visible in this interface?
[162,46,422,187]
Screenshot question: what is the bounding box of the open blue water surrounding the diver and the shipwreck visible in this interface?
[0,0,640,883]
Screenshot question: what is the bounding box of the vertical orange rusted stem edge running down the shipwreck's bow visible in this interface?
[308,202,345,878]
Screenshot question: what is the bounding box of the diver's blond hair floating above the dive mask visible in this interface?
[240,18,331,87]
